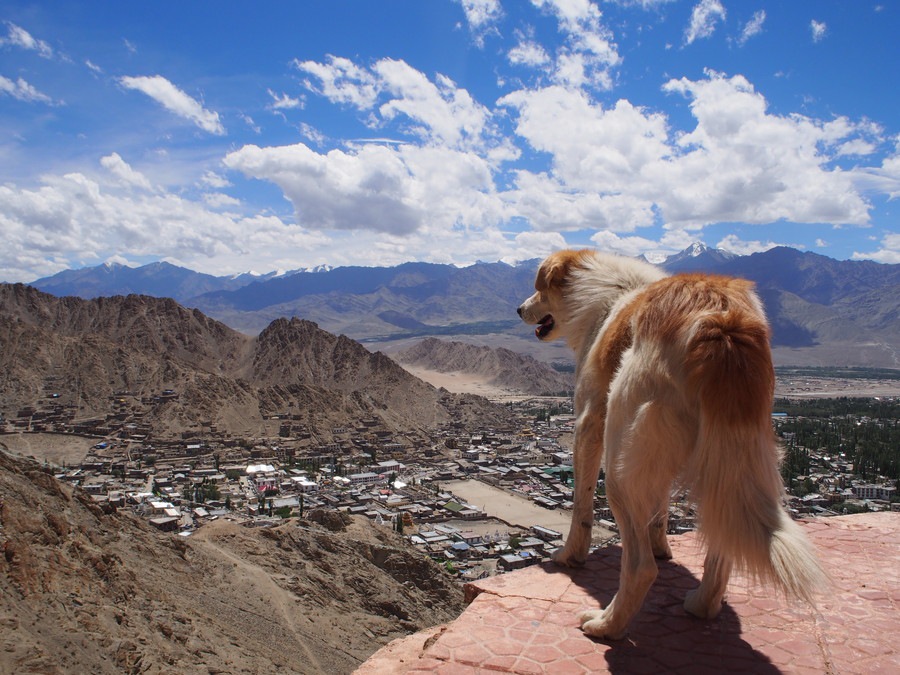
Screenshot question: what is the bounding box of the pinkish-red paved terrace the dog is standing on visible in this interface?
[357,513,900,675]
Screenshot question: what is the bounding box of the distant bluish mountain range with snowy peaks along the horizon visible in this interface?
[32,244,900,368]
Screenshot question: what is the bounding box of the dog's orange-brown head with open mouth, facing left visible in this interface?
[518,249,593,341]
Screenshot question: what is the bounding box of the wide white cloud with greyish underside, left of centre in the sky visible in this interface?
[224,143,504,237]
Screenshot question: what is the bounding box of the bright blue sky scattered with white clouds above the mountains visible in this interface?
[0,0,900,281]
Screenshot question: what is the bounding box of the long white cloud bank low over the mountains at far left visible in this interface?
[0,161,327,281]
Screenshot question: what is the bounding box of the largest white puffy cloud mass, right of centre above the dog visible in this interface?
[500,72,876,240]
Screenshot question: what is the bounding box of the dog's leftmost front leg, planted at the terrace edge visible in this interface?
[552,407,603,567]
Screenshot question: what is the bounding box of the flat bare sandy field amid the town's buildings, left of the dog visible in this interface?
[441,480,614,541]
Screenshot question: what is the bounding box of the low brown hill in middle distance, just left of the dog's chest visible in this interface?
[396,338,574,395]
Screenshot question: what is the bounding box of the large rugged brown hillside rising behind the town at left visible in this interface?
[0,284,504,440]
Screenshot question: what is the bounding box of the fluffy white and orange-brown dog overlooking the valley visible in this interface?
[518,249,826,639]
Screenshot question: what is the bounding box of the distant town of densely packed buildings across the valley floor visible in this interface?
[0,390,900,579]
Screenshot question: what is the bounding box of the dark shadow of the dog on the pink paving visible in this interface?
[564,546,781,674]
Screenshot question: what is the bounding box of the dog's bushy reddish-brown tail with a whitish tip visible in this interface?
[686,310,826,602]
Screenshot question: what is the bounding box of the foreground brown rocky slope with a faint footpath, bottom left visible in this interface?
[0,452,463,675]
